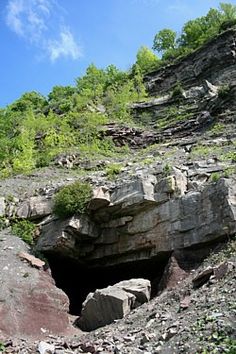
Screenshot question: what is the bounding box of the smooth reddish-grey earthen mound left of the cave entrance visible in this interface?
[0,232,70,338]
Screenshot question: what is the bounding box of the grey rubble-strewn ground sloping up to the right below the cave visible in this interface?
[0,235,236,354]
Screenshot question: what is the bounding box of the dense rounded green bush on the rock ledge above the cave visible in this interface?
[53,181,92,218]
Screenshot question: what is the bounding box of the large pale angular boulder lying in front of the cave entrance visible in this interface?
[77,279,151,331]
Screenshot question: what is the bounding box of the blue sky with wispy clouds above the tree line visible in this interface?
[0,0,236,107]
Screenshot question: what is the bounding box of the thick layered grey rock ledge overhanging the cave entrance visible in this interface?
[37,176,236,266]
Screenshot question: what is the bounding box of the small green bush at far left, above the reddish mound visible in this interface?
[11,220,37,245]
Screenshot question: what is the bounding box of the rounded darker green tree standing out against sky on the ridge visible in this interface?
[152,28,177,52]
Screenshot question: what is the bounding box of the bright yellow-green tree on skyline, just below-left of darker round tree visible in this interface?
[136,46,160,74]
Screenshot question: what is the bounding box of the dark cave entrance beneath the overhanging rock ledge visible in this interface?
[47,253,170,316]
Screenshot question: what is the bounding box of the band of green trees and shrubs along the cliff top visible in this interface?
[0,3,236,177]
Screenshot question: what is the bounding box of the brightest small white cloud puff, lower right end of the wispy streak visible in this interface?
[48,28,82,62]
